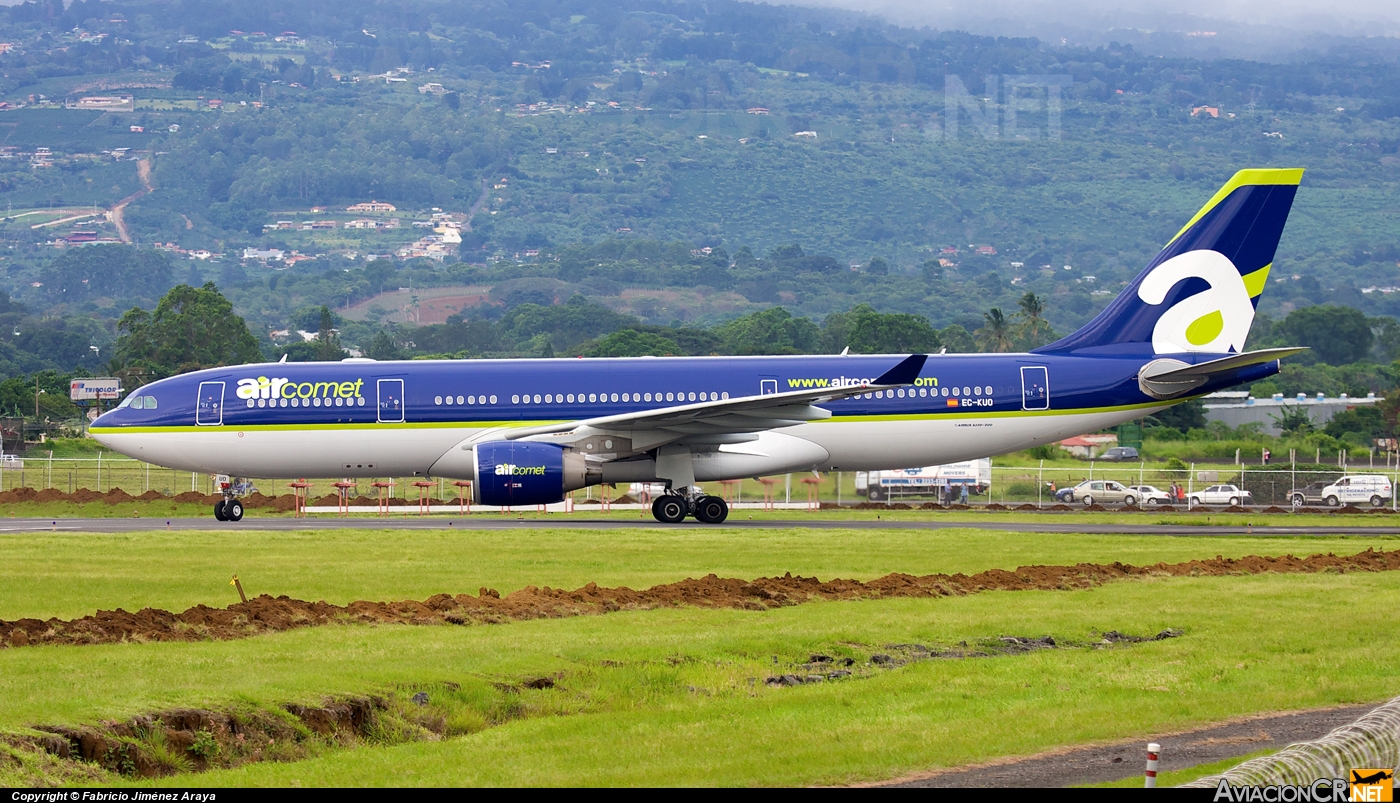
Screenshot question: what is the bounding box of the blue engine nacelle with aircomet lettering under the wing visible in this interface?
[472,441,588,506]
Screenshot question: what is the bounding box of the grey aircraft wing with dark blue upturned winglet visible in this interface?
[505,354,928,452]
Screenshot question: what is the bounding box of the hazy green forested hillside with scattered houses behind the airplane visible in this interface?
[0,0,1400,453]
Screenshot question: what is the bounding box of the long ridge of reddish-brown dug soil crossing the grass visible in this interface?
[0,548,1400,648]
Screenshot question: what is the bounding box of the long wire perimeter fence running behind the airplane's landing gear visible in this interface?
[0,453,1400,509]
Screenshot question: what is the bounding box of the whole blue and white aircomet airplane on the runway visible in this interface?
[90,169,1303,523]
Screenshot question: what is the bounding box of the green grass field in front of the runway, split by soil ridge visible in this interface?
[0,527,1400,785]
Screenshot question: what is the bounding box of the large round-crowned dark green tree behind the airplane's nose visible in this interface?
[112,283,263,379]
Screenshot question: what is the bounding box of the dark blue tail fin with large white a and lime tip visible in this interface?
[1036,168,1303,354]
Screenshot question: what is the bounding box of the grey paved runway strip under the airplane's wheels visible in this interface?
[0,513,1400,537]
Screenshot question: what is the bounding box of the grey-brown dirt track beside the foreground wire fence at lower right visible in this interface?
[879,705,1375,789]
